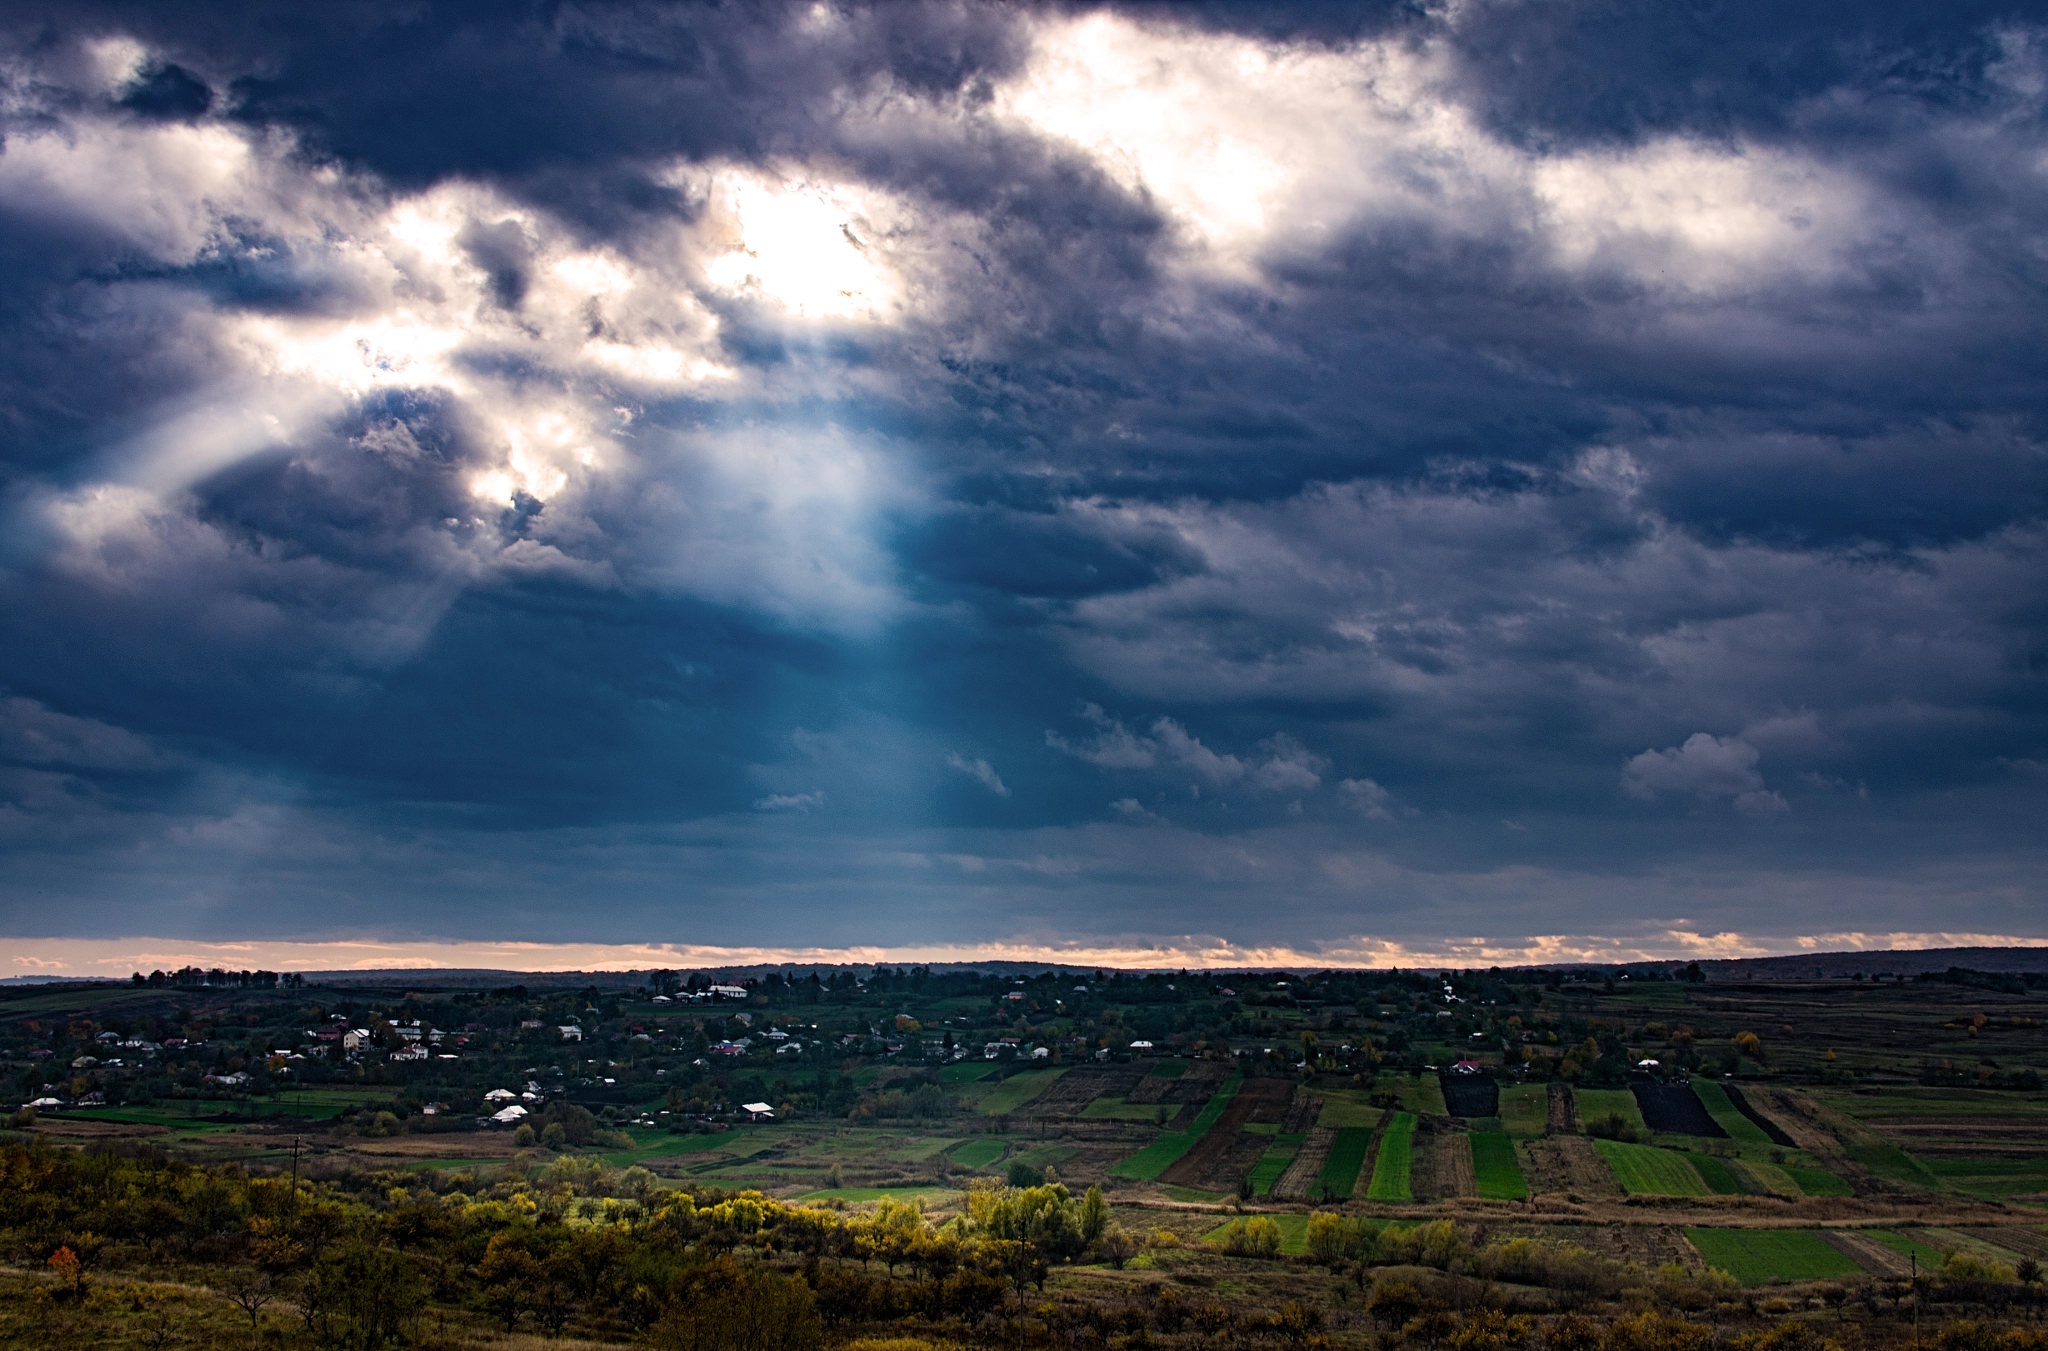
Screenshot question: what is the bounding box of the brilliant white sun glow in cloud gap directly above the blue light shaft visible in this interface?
[705,176,895,319]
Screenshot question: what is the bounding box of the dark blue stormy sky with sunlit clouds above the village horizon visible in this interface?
[0,0,2048,974]
